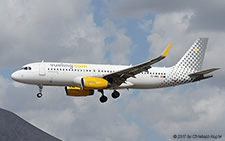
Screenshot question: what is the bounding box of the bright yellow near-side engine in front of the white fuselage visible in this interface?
[81,77,110,89]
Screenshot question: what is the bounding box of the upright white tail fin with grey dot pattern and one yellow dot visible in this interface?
[175,38,208,73]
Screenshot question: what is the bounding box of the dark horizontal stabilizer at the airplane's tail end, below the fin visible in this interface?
[189,68,219,82]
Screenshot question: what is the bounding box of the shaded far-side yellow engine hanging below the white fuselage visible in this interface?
[65,87,94,97]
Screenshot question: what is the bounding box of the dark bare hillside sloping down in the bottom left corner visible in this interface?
[0,108,59,141]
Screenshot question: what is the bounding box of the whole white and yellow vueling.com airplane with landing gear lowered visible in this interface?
[11,38,219,103]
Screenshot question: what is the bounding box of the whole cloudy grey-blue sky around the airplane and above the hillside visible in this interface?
[0,0,225,141]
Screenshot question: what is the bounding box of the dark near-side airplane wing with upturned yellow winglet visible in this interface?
[103,43,172,85]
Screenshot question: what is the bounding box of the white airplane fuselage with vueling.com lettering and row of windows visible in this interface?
[12,62,172,89]
